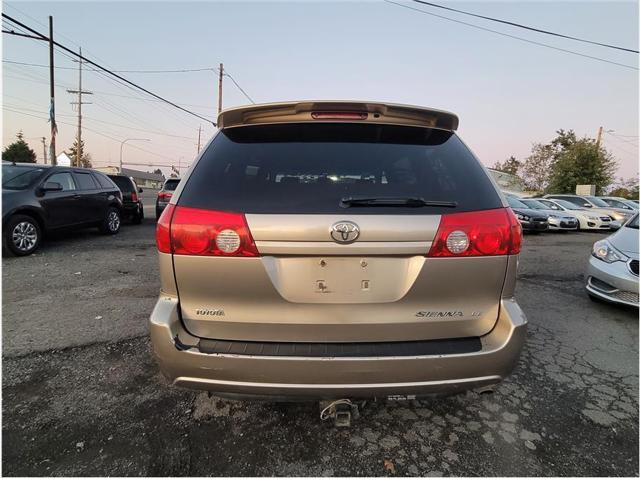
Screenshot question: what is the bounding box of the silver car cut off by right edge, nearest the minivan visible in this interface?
[586,213,639,307]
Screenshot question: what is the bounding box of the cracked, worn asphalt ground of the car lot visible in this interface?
[2,222,638,476]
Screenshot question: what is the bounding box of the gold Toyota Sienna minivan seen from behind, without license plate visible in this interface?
[150,101,527,400]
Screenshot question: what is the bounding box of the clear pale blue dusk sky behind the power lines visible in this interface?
[2,0,639,178]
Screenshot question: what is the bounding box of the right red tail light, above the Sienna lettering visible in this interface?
[427,208,522,257]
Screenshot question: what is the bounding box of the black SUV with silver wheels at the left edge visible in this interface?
[2,162,122,256]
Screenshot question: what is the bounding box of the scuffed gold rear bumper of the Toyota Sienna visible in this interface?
[150,296,527,399]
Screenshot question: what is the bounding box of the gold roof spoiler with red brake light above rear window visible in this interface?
[218,101,458,131]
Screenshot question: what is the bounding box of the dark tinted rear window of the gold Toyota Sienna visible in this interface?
[179,123,502,214]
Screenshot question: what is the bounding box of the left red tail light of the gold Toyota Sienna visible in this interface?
[156,204,260,257]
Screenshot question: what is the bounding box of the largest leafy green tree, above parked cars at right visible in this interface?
[548,136,617,194]
